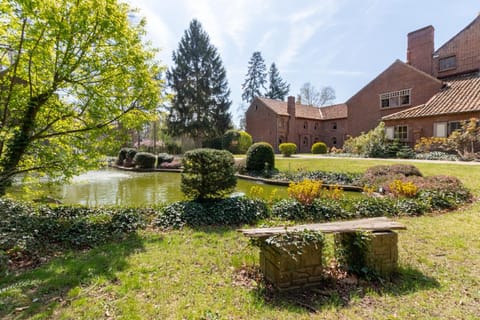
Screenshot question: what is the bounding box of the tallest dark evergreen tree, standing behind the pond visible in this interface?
[167,20,232,146]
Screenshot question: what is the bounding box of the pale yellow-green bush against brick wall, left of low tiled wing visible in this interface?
[343,122,387,158]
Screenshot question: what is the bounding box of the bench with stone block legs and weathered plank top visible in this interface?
[238,217,406,290]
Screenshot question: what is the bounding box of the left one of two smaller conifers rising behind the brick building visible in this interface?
[242,51,267,103]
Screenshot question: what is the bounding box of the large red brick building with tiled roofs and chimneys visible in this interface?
[246,15,480,152]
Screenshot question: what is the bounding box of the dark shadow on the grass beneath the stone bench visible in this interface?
[252,268,440,313]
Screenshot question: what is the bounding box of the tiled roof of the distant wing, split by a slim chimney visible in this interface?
[257,97,347,120]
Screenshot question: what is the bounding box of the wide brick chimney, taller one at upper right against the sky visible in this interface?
[407,26,435,75]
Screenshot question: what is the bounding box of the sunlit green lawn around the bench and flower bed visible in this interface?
[0,158,480,319]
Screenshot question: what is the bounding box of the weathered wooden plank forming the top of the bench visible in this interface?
[238,217,407,238]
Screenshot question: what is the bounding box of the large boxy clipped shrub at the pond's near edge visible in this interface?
[181,149,237,200]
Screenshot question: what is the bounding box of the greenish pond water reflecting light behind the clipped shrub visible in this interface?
[9,169,287,206]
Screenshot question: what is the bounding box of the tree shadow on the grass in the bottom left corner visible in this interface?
[0,234,158,319]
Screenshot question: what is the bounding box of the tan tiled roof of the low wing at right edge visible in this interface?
[382,73,480,120]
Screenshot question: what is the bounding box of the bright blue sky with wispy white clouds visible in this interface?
[128,0,480,123]
